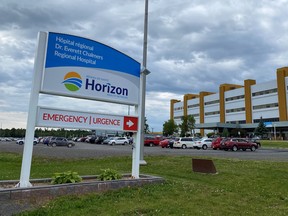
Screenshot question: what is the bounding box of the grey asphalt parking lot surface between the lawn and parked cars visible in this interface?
[0,141,288,161]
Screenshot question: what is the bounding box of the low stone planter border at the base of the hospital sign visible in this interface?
[0,175,165,215]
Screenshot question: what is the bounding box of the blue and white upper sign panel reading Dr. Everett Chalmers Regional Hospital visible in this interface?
[41,32,141,105]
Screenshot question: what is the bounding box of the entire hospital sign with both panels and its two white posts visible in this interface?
[17,32,143,187]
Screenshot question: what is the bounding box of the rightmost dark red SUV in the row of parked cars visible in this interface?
[220,138,258,151]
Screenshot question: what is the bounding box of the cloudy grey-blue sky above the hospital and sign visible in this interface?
[0,0,288,132]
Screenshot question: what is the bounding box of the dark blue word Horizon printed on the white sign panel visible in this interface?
[85,78,129,96]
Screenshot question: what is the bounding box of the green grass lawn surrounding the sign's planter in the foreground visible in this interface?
[0,153,288,216]
